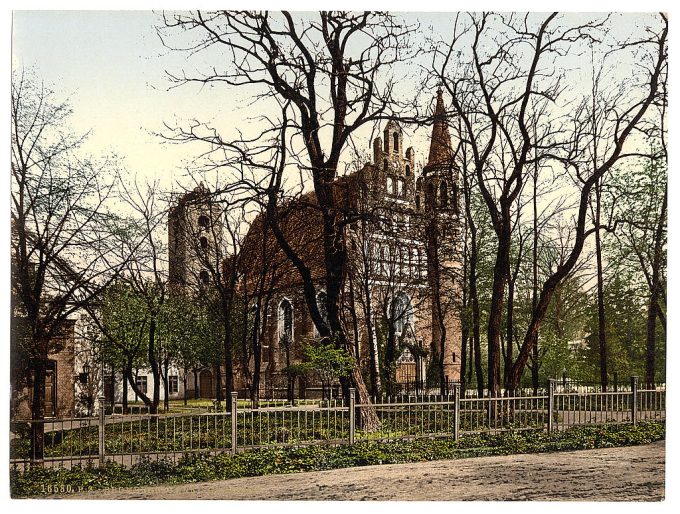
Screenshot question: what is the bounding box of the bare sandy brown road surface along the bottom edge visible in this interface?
[63,441,665,501]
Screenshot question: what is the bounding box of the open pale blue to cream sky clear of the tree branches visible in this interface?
[12,11,660,193]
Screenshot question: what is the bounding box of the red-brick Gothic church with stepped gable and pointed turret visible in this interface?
[170,91,461,398]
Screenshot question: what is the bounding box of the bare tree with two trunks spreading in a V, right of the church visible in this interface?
[435,13,667,396]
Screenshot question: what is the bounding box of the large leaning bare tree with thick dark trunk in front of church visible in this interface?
[159,12,422,426]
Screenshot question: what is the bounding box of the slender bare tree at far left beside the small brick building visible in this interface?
[11,73,134,460]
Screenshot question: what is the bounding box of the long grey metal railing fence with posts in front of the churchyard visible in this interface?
[10,378,666,467]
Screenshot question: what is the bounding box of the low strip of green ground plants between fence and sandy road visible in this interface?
[10,422,665,498]
